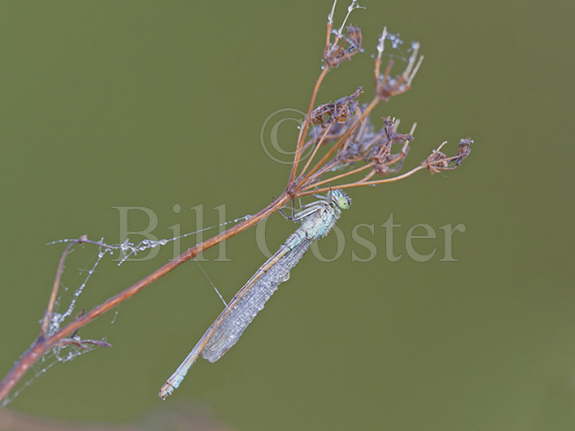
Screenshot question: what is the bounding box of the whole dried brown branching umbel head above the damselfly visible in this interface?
[288,0,472,197]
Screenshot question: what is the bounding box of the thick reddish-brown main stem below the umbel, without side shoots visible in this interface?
[0,192,290,405]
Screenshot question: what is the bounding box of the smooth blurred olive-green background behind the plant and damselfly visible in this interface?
[0,0,575,431]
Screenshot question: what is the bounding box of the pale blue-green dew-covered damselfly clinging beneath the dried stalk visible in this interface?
[159,190,351,399]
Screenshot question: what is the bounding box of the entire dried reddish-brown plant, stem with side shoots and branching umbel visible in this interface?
[0,0,473,401]
